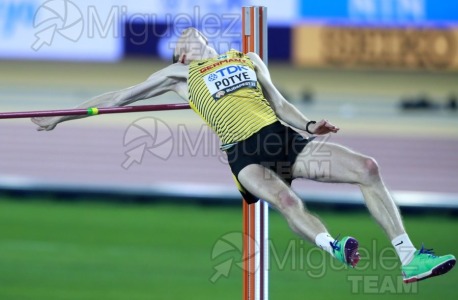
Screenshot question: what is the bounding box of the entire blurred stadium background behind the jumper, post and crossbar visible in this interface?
[0,0,458,300]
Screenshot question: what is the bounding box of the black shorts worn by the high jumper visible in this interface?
[226,121,310,204]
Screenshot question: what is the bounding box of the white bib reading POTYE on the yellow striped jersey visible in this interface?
[204,65,258,101]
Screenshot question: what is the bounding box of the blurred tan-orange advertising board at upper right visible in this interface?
[293,25,458,70]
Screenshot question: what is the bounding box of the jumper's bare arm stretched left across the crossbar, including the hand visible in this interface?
[32,63,188,130]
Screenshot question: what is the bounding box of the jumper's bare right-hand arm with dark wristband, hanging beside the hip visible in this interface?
[248,53,339,134]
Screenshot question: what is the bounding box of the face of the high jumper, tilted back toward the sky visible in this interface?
[182,29,218,64]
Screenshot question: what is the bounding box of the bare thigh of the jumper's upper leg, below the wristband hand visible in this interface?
[292,141,368,183]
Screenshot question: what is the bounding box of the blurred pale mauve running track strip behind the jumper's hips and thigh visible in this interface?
[0,123,458,199]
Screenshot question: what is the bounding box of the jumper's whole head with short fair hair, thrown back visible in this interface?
[173,27,218,64]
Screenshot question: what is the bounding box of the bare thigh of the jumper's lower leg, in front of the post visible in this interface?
[237,164,300,208]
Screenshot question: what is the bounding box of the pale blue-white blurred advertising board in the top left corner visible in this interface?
[0,0,122,61]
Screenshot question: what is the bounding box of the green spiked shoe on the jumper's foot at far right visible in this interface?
[402,246,456,283]
